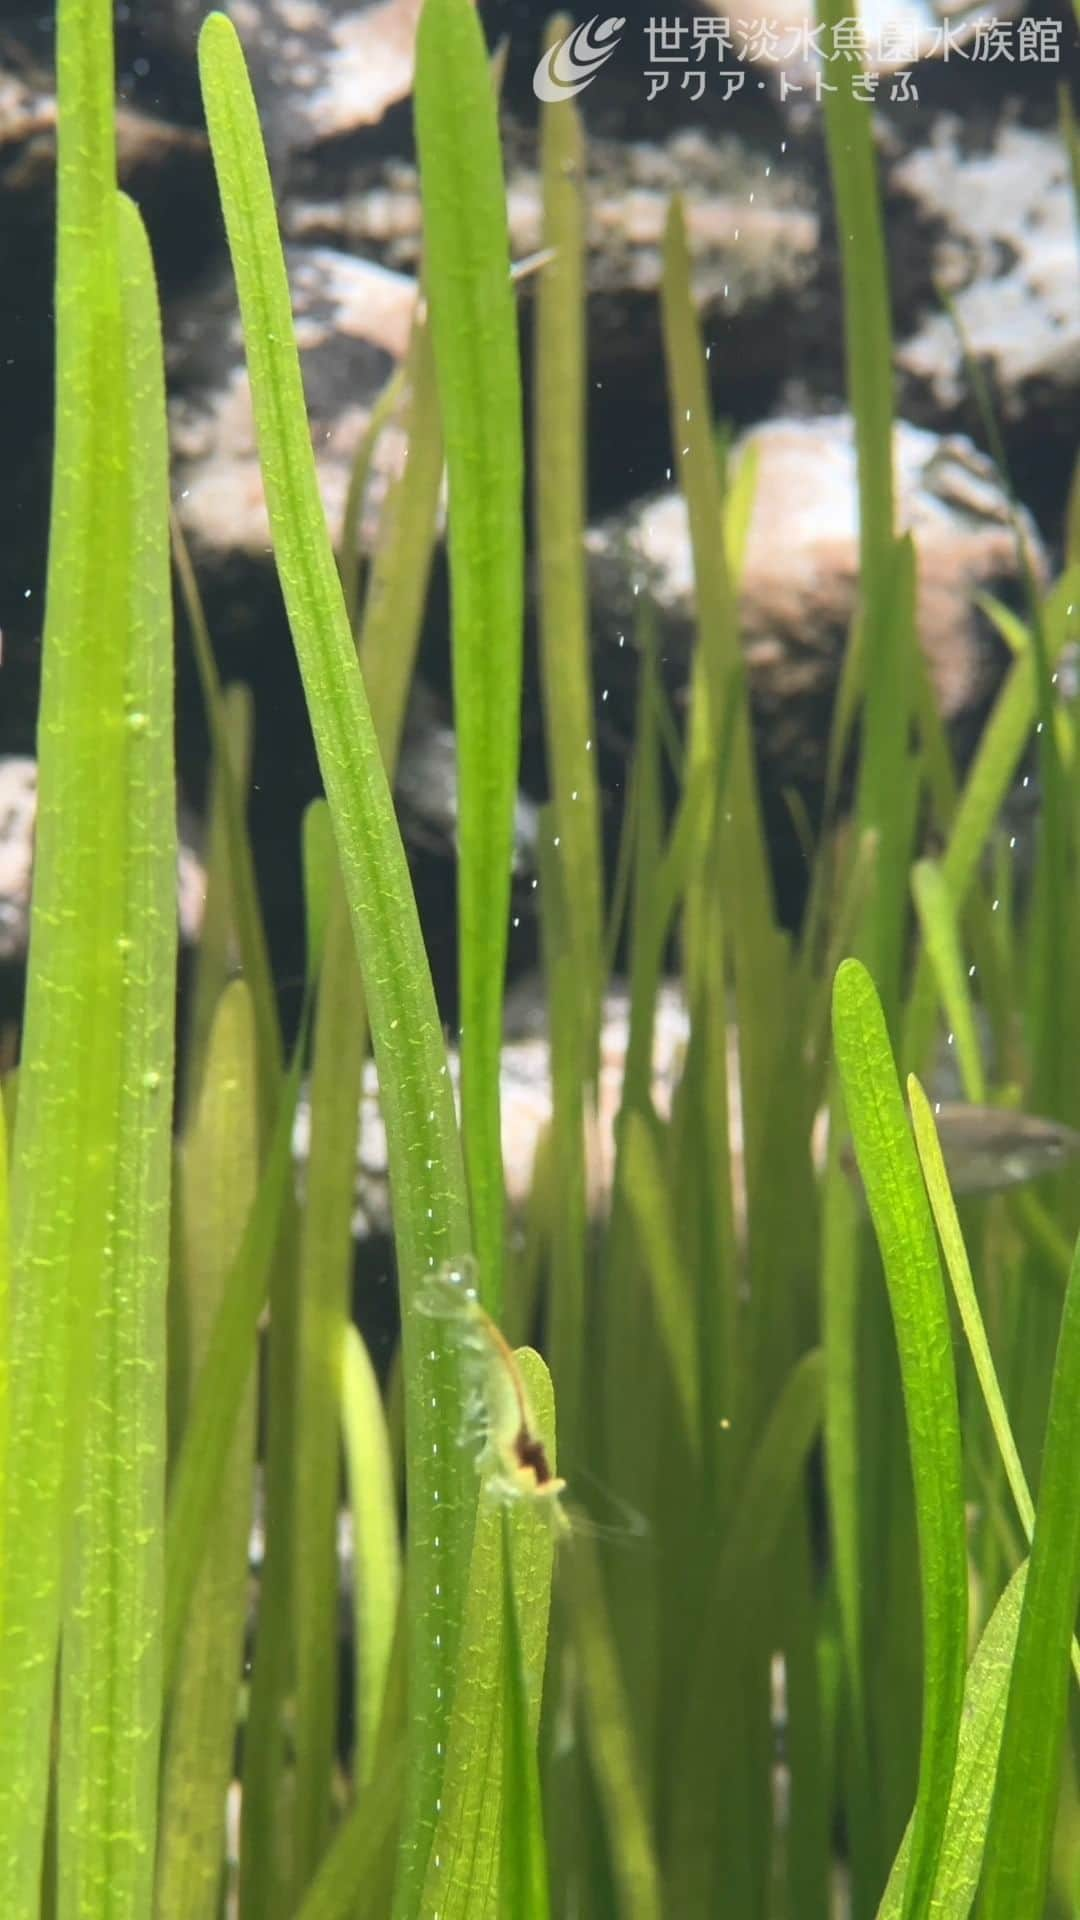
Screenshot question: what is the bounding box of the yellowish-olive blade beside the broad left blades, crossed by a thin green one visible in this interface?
[154,981,258,1920]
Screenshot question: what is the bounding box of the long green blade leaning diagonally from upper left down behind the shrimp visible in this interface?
[200,13,475,1916]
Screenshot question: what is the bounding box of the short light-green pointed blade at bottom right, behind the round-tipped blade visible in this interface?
[878,1561,1028,1920]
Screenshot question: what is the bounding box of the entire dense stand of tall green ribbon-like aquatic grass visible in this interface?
[0,0,1080,1920]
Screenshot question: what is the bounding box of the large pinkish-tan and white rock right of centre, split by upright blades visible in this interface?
[586,415,1045,783]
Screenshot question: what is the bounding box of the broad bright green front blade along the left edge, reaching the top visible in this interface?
[0,0,159,1914]
